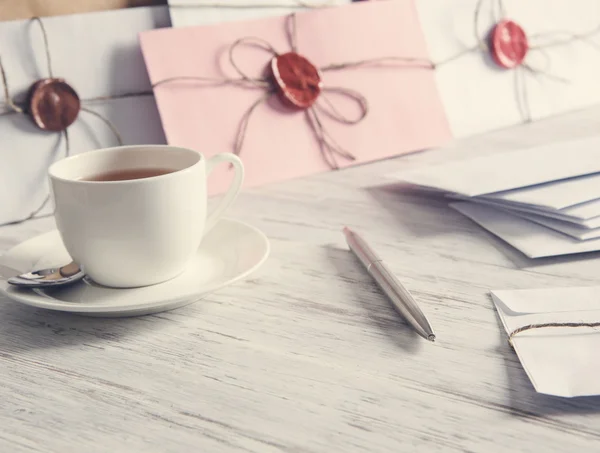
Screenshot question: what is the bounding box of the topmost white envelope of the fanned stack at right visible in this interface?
[390,135,600,197]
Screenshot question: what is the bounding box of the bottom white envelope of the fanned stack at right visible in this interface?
[450,202,600,258]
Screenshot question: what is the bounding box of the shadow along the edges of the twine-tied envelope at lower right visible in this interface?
[496,308,600,418]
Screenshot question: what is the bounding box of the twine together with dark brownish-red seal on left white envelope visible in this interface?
[0,17,130,224]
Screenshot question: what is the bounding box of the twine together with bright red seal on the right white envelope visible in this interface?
[435,0,600,123]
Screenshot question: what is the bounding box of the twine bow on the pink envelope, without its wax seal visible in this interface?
[153,13,433,169]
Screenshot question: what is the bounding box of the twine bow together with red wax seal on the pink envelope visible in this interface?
[152,13,433,170]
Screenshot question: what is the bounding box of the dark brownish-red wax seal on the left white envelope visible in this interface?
[28,79,81,132]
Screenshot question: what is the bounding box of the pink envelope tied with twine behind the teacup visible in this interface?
[140,0,451,194]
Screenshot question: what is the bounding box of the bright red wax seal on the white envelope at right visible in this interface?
[491,20,529,69]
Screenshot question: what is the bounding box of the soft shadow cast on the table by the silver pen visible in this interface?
[325,245,426,354]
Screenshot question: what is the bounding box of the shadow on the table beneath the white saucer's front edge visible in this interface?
[0,298,186,355]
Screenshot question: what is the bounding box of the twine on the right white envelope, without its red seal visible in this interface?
[435,0,600,122]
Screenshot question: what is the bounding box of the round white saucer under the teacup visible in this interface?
[0,220,269,317]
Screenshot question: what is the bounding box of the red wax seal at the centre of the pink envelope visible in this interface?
[271,52,322,109]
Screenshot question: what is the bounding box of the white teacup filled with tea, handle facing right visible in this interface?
[49,145,244,288]
